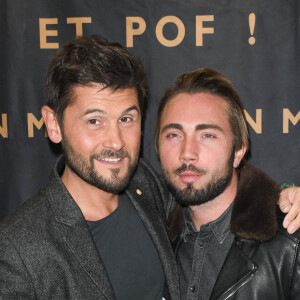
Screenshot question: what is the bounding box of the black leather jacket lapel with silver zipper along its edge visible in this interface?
[210,241,258,300]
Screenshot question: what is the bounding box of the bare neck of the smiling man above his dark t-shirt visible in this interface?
[61,165,119,221]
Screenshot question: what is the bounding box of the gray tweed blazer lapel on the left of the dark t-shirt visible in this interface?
[47,159,116,300]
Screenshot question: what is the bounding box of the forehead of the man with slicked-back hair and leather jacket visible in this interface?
[161,93,230,129]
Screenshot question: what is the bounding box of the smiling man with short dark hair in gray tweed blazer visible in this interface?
[0,36,179,300]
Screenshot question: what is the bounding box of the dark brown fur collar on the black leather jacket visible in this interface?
[168,163,280,242]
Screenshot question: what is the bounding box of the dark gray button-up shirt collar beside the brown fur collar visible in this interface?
[182,203,233,244]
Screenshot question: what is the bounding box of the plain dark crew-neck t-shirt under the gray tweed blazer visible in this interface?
[88,194,165,300]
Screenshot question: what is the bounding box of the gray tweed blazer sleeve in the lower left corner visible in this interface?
[0,235,36,299]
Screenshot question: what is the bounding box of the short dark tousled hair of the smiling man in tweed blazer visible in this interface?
[46,35,147,125]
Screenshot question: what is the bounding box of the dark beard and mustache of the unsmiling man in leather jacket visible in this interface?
[163,151,235,206]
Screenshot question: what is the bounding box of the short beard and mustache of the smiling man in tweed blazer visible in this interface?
[61,136,139,194]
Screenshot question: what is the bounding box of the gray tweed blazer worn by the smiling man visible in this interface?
[0,158,179,300]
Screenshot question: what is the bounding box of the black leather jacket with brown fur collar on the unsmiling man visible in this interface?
[170,164,300,300]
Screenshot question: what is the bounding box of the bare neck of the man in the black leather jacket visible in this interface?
[189,171,238,231]
